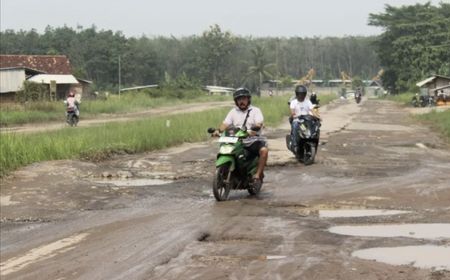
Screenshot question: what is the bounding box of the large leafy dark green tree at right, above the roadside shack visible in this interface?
[369,2,450,91]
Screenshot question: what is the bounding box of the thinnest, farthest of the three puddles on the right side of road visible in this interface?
[319,209,411,218]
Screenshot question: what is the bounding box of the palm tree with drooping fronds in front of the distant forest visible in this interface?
[246,45,276,96]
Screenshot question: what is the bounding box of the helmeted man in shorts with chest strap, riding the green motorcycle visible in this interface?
[213,88,269,184]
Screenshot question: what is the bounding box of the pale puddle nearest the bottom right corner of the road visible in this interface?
[352,245,450,270]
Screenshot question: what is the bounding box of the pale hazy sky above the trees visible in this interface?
[0,0,450,37]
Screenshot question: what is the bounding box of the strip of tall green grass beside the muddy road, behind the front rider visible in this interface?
[0,97,288,176]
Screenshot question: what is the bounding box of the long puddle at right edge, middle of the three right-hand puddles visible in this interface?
[329,224,450,239]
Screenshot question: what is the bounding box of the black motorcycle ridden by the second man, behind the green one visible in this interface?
[286,115,320,165]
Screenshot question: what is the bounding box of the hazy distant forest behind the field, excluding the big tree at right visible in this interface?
[0,25,379,89]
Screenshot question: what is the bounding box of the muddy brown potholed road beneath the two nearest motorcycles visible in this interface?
[0,97,450,280]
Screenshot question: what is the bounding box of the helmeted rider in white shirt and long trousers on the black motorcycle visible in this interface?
[289,85,319,153]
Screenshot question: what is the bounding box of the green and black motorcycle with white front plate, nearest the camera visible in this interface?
[208,127,263,201]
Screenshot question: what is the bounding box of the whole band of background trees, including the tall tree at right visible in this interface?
[0,3,450,92]
